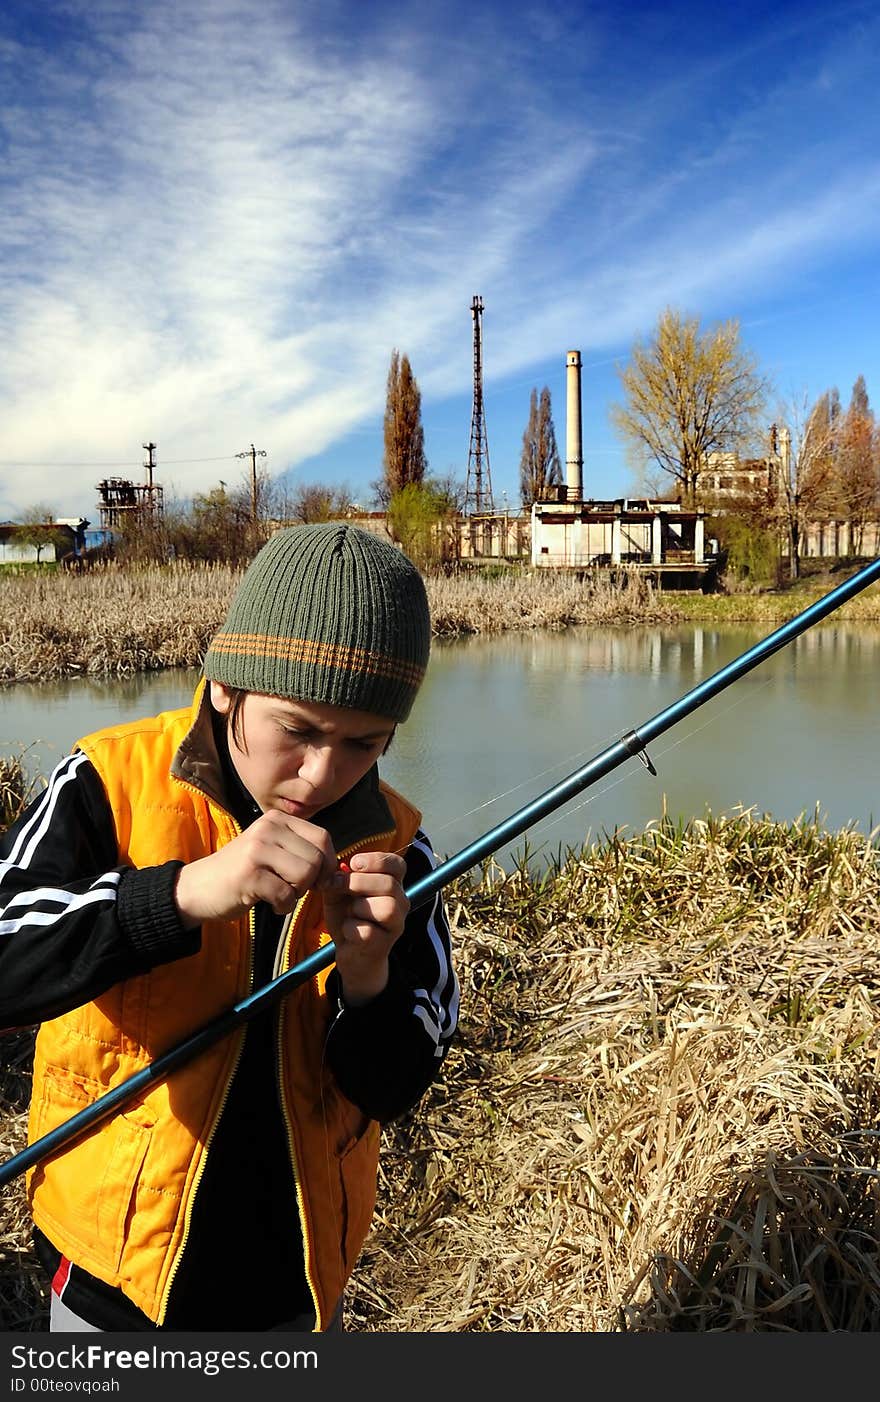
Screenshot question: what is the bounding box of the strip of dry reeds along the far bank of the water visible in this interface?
[0,564,880,684]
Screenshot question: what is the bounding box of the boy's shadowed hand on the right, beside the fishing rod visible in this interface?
[322,852,409,1007]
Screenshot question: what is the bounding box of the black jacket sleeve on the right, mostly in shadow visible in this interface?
[326,831,458,1123]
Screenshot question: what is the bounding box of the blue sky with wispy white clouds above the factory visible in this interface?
[0,0,880,523]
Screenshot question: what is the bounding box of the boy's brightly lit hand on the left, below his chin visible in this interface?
[175,809,336,930]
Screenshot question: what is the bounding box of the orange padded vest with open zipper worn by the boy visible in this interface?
[27,684,420,1330]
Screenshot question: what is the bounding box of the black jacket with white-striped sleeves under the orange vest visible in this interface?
[0,706,458,1329]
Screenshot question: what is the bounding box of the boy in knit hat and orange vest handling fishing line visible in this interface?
[0,523,458,1330]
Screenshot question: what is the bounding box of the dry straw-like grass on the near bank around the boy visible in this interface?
[0,813,880,1333]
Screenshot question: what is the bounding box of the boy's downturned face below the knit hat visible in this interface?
[210,681,395,819]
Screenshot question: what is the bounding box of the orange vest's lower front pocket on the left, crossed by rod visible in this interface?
[31,1066,150,1276]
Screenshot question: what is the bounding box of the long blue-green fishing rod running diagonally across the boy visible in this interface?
[0,558,880,1187]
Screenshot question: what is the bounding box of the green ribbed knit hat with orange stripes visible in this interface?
[203,522,430,721]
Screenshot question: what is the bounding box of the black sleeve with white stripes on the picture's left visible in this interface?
[0,751,200,1028]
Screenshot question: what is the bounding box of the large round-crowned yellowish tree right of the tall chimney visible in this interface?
[611,307,768,506]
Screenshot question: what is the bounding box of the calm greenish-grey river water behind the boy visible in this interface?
[0,622,880,865]
